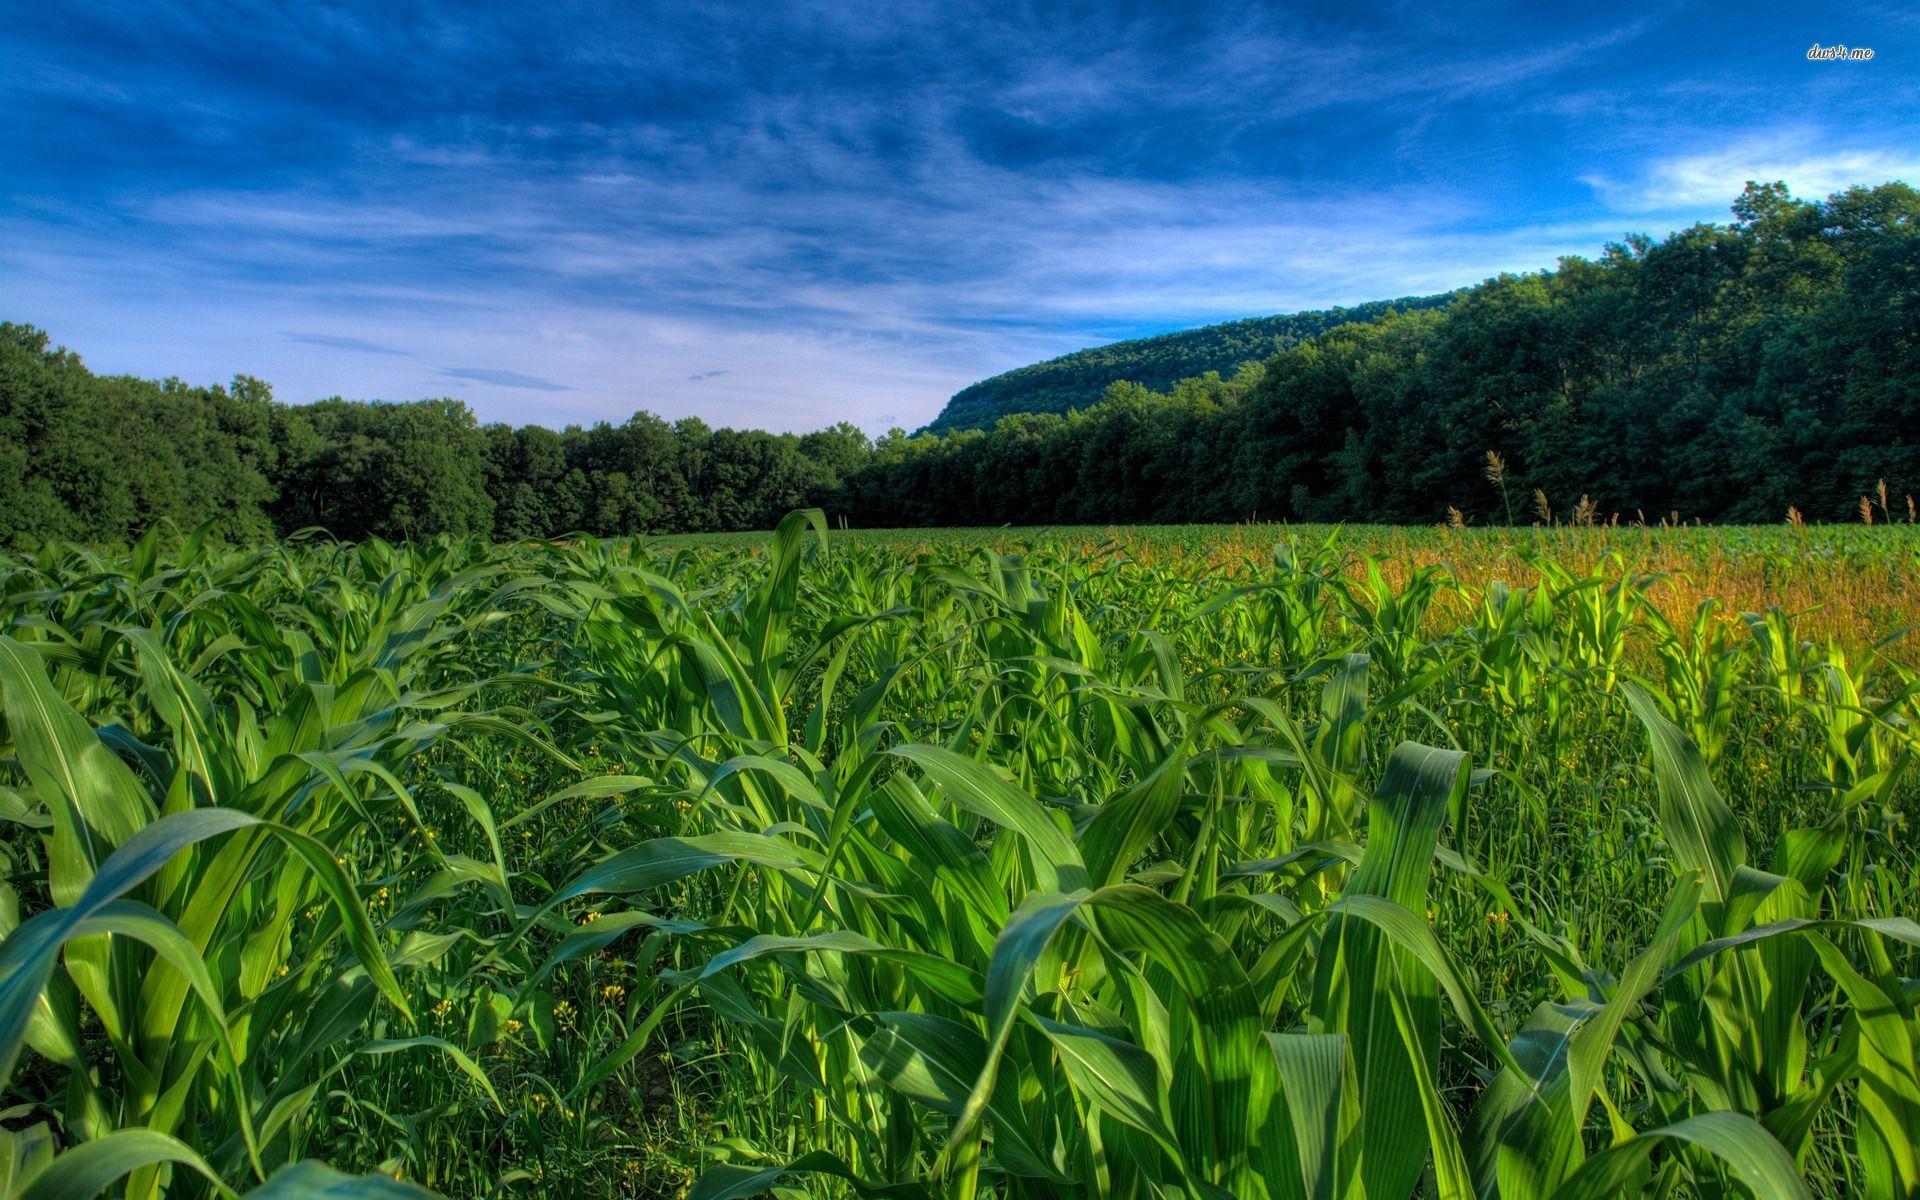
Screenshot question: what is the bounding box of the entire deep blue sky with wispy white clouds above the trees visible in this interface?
[0,0,1920,432]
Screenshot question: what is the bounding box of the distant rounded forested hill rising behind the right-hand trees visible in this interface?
[927,292,1455,432]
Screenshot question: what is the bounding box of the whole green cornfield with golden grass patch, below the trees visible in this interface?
[0,515,1920,1200]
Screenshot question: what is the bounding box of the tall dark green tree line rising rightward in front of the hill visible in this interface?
[864,182,1920,524]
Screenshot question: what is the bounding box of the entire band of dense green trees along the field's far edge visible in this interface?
[0,184,1920,545]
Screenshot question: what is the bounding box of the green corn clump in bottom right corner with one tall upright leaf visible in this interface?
[1469,685,1920,1198]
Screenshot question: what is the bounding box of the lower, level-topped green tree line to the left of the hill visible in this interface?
[0,324,872,545]
